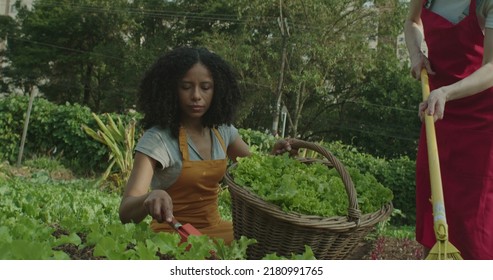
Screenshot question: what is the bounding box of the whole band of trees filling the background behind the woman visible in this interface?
[2,0,419,156]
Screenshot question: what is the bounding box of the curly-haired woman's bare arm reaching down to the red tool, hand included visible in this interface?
[119,152,173,223]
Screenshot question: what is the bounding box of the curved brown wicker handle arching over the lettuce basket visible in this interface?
[288,138,361,225]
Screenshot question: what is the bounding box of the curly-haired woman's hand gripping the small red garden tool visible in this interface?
[144,190,173,223]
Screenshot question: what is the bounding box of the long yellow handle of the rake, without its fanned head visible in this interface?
[421,69,448,240]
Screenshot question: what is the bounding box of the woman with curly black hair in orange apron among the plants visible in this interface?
[119,47,290,244]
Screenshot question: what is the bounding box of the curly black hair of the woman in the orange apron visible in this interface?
[137,47,242,137]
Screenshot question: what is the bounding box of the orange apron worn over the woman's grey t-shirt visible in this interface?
[150,127,233,244]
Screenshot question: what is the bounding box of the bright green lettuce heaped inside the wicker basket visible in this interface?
[229,153,393,217]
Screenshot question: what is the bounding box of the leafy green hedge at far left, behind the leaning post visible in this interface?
[0,95,141,174]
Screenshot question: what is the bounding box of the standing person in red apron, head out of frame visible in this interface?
[405,0,493,259]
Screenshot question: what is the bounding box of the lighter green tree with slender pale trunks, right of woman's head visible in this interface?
[203,0,376,133]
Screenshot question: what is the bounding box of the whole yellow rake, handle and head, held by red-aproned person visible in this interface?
[421,69,462,260]
